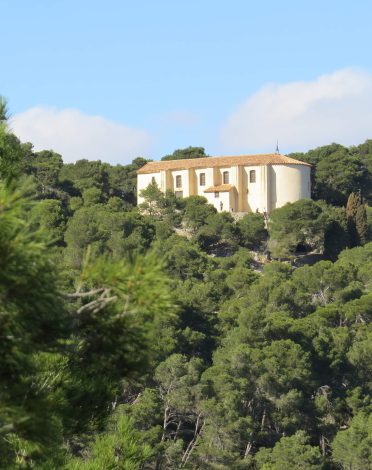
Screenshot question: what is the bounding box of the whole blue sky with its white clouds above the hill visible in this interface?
[0,0,372,164]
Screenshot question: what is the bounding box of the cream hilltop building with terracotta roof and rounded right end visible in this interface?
[137,154,311,213]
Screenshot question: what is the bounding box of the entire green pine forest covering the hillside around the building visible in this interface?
[0,96,372,470]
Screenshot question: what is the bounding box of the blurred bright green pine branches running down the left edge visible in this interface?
[0,183,66,462]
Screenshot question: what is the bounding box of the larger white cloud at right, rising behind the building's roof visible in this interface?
[221,69,372,152]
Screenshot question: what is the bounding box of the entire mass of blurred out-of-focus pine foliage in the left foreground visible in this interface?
[0,187,174,468]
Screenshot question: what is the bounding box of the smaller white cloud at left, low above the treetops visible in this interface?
[10,107,152,164]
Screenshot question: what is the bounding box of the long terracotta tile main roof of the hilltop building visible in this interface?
[137,153,311,174]
